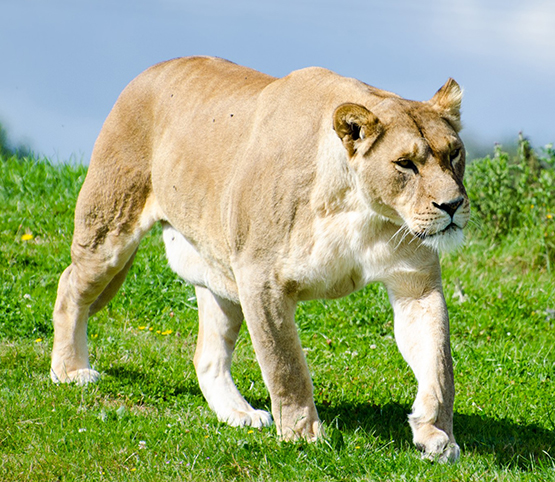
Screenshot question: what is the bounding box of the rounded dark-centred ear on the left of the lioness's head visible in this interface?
[333,104,382,157]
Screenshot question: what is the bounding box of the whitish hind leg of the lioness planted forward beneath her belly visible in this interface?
[194,287,272,427]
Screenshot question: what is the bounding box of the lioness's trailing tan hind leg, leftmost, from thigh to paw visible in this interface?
[51,171,160,384]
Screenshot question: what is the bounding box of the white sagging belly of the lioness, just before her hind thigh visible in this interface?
[163,224,239,301]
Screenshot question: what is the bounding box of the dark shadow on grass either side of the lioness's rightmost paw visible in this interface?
[318,403,555,471]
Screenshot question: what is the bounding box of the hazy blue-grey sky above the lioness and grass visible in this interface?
[0,0,555,163]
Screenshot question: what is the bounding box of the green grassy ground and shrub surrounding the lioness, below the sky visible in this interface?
[0,141,555,482]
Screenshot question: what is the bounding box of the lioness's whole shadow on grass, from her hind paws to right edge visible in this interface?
[97,365,555,471]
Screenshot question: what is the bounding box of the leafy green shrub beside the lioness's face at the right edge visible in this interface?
[466,136,555,270]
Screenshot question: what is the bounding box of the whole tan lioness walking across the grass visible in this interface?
[51,57,469,460]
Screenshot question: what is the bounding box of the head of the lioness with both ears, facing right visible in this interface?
[334,79,470,250]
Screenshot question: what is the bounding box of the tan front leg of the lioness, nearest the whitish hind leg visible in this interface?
[236,269,321,440]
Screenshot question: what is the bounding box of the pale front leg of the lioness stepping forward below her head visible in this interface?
[389,288,460,462]
